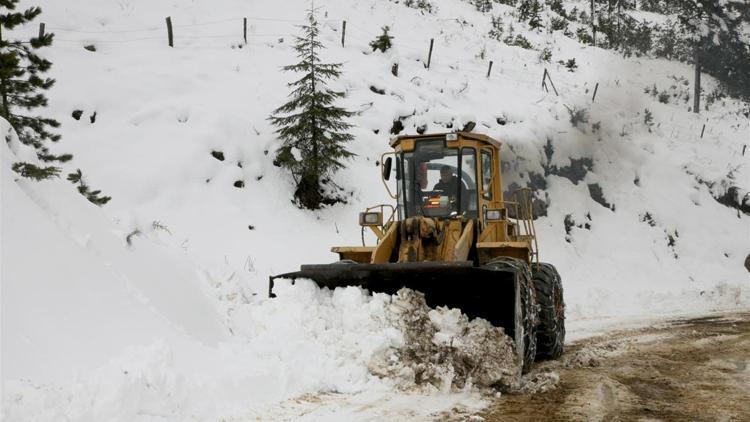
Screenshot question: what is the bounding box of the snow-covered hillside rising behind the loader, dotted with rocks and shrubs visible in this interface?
[0,0,750,420]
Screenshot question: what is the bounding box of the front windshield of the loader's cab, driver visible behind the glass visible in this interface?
[398,140,477,219]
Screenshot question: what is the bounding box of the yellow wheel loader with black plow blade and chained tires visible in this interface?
[269,132,565,371]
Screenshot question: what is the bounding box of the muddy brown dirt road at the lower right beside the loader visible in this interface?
[482,313,750,421]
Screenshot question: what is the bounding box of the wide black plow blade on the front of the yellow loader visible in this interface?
[269,261,517,337]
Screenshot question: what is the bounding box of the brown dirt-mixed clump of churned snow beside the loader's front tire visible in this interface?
[370,289,520,392]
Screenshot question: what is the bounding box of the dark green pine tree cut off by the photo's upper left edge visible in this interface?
[0,0,73,180]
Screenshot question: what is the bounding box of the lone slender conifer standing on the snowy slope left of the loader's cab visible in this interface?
[269,9,354,209]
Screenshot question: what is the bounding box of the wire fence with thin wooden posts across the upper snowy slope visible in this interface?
[7,16,748,145]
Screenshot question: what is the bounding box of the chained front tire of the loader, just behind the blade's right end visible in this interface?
[484,257,539,373]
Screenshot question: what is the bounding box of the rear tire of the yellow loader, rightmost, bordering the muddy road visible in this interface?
[531,263,565,360]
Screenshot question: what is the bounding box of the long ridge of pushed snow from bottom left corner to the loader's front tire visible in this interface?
[3,280,518,421]
